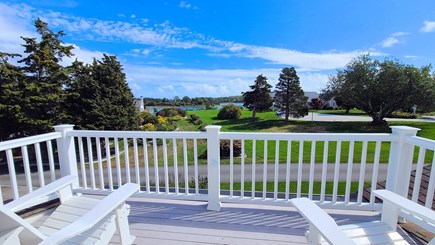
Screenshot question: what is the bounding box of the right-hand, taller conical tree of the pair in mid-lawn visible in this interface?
[274,67,308,123]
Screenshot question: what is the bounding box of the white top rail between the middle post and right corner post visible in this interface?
[219,132,399,142]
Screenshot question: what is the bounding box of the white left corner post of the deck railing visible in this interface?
[53,124,79,188]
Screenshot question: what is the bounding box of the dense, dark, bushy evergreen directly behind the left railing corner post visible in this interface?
[65,54,138,130]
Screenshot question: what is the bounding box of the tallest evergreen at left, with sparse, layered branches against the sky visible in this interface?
[18,19,73,135]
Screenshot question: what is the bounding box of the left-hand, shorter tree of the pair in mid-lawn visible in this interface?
[242,74,273,122]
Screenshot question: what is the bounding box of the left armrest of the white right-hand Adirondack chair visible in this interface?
[290,197,355,244]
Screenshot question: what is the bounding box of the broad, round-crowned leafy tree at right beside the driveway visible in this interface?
[328,55,435,125]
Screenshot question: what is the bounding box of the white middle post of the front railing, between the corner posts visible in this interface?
[205,125,221,211]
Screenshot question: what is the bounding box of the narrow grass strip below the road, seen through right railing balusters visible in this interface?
[221,181,369,195]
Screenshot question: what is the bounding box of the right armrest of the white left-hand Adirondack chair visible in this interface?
[40,183,140,245]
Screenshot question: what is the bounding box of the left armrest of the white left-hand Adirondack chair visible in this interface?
[5,175,77,212]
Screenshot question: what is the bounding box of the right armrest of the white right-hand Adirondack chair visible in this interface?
[373,190,435,227]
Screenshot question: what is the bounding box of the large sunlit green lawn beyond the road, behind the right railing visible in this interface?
[179,110,435,163]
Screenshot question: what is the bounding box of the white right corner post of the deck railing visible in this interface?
[386,126,420,198]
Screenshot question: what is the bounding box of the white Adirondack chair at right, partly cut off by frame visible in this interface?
[290,190,435,245]
